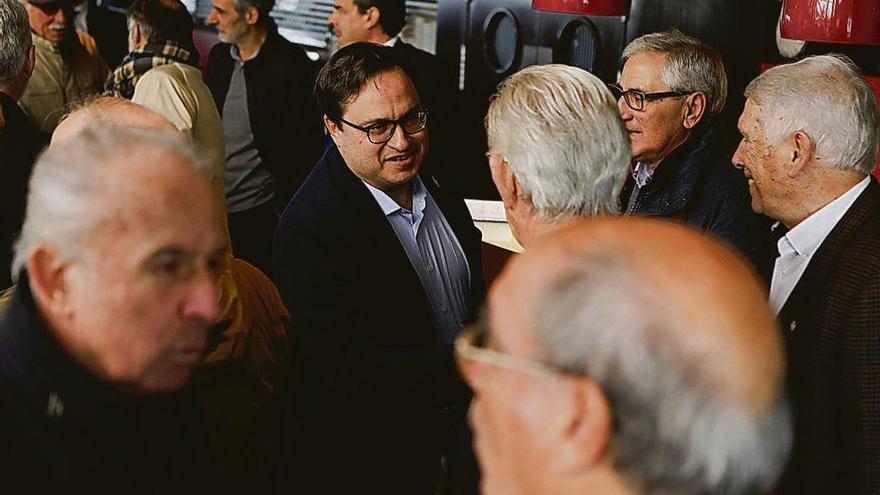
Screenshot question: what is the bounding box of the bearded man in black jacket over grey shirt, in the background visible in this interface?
[205,0,324,273]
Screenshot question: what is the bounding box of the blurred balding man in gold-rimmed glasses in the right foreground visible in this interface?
[456,217,791,495]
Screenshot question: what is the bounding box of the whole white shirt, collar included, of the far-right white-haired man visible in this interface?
[770,176,871,314]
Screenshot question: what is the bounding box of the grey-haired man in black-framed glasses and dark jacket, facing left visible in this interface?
[611,30,766,263]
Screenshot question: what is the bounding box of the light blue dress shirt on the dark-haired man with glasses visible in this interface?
[364,177,471,344]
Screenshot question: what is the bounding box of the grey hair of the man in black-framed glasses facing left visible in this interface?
[620,29,727,115]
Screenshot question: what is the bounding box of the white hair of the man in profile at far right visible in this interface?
[745,55,880,175]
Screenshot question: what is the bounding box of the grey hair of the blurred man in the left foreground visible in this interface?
[12,124,213,278]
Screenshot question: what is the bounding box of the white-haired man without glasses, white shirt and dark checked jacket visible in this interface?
[733,55,880,495]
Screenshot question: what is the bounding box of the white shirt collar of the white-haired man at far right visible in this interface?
[779,176,871,258]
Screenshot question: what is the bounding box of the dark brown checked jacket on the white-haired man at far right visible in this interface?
[779,178,880,495]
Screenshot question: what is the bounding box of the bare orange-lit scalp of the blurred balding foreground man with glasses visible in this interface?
[516,218,783,407]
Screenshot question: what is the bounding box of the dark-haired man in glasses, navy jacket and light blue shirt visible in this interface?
[273,42,485,495]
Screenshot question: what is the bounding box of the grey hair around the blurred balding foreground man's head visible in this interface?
[530,253,791,495]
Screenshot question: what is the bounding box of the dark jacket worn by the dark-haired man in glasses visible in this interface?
[274,146,485,495]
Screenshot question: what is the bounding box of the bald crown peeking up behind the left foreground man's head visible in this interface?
[52,96,177,145]
